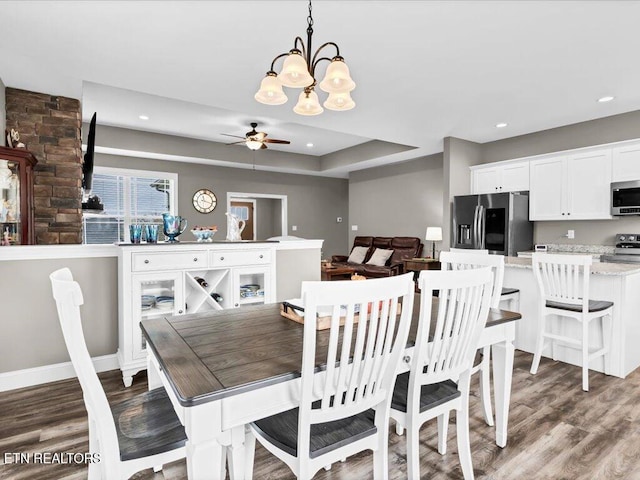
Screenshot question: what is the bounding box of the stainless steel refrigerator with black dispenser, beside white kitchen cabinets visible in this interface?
[451,192,533,256]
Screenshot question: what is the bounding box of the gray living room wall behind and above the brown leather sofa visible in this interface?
[344,154,442,256]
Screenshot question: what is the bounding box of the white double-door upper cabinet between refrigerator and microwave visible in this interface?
[529,148,612,221]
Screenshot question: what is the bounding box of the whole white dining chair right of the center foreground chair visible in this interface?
[391,267,493,480]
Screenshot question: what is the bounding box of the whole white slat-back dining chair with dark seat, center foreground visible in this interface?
[246,273,414,479]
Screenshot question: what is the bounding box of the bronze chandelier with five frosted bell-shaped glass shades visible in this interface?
[254,0,356,115]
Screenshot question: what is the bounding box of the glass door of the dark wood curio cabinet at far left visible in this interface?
[0,159,23,245]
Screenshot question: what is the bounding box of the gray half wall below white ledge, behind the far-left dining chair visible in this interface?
[0,257,118,373]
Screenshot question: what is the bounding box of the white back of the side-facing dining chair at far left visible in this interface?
[49,268,120,461]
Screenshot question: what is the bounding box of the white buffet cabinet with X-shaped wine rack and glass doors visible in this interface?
[117,242,278,387]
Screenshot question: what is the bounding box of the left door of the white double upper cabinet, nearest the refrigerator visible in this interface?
[529,157,567,220]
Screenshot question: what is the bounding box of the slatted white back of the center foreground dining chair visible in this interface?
[298,274,414,436]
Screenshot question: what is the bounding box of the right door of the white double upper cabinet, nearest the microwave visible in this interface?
[566,148,611,220]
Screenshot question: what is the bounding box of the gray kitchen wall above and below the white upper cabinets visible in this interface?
[477,111,640,245]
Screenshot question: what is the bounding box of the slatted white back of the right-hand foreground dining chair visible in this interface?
[410,267,493,384]
